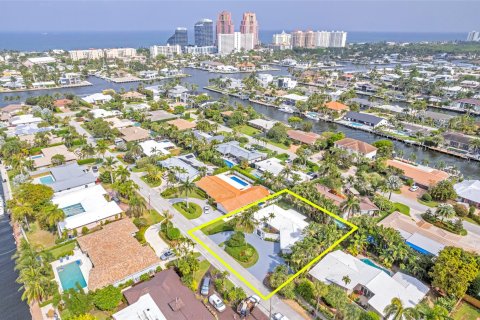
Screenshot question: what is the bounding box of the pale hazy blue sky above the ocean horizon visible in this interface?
[0,0,480,32]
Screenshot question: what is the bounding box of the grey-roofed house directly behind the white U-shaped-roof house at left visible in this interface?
[31,162,97,194]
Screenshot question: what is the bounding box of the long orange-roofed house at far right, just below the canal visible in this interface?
[387,159,450,189]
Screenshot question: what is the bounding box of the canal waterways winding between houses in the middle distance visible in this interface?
[0,65,480,179]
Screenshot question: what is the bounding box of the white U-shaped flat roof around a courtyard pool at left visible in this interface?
[52,185,122,230]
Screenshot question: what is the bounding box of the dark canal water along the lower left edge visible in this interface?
[0,176,31,320]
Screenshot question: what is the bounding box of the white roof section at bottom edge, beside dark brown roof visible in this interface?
[112,293,167,320]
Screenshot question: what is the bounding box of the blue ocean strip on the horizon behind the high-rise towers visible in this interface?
[0,30,467,51]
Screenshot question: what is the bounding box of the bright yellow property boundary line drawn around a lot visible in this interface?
[188,189,358,300]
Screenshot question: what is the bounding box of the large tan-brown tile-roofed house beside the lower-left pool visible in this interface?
[77,219,160,290]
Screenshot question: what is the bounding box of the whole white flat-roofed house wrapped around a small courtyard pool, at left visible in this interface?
[52,185,122,234]
